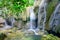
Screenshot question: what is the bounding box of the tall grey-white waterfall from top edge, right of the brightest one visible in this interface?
[38,0,47,31]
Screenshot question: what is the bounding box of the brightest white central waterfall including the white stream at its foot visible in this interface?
[28,8,38,35]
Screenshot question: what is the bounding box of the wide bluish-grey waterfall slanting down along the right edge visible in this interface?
[49,3,60,31]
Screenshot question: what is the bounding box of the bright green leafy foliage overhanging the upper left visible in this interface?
[0,0,34,18]
